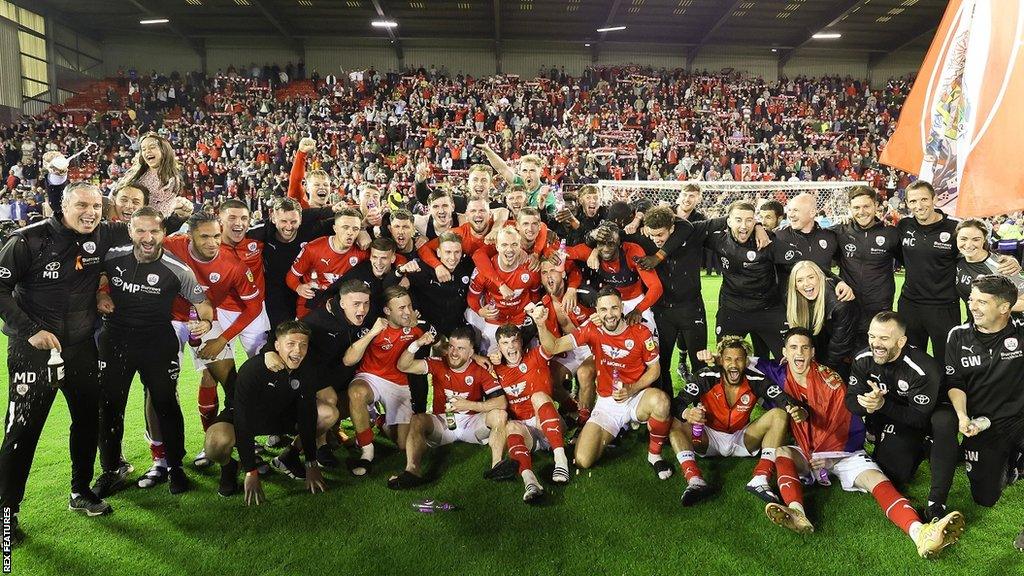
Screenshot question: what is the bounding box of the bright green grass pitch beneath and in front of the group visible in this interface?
[0,278,1024,576]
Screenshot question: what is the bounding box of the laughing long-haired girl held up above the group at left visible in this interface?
[119,132,183,217]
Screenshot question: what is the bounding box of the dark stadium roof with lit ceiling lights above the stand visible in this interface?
[13,0,946,57]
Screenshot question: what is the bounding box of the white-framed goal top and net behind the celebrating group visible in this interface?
[597,180,868,220]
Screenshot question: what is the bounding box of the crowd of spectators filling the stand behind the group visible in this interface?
[0,63,1020,236]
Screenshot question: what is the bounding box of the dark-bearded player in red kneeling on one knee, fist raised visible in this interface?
[530,287,672,480]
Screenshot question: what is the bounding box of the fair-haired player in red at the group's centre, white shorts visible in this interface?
[467,228,541,354]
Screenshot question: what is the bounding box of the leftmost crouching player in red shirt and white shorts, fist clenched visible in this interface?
[342,286,424,476]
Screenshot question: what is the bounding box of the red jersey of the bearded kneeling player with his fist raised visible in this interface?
[569,322,658,397]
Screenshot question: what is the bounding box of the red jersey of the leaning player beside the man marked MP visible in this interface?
[164,236,263,339]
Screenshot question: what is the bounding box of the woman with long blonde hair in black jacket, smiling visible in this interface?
[785,260,859,378]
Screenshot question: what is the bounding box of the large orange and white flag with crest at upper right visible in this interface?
[880,0,1024,216]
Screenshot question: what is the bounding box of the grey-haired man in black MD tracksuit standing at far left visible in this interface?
[0,182,128,539]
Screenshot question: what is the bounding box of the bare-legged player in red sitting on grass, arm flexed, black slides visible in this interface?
[387,326,508,490]
